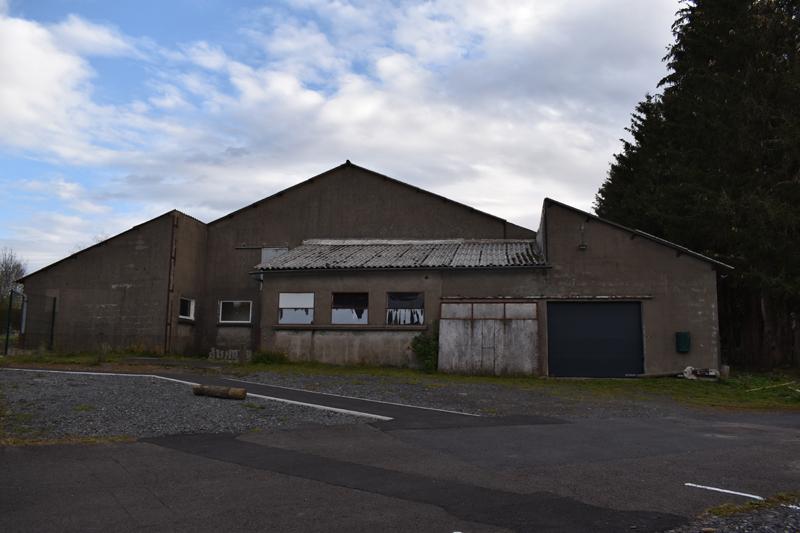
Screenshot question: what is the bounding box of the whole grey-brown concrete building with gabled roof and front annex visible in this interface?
[21,161,729,376]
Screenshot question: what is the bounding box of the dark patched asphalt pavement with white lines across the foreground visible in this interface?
[0,368,800,532]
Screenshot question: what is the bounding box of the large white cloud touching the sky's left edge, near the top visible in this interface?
[0,17,168,165]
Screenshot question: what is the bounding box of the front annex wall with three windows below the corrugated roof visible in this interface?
[259,269,543,368]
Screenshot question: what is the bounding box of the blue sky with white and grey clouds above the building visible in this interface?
[0,0,678,269]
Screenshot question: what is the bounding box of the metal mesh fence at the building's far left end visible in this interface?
[0,292,57,355]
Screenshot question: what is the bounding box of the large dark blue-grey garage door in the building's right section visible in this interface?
[547,302,644,377]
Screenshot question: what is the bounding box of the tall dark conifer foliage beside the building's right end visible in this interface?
[595,0,800,366]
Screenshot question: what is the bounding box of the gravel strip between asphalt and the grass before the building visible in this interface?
[236,372,688,419]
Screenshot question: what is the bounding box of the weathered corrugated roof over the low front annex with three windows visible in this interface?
[256,239,544,271]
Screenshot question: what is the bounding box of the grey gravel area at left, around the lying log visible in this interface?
[0,370,370,438]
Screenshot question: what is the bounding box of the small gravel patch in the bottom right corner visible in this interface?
[668,507,800,533]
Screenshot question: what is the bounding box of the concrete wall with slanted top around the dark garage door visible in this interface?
[541,204,719,374]
